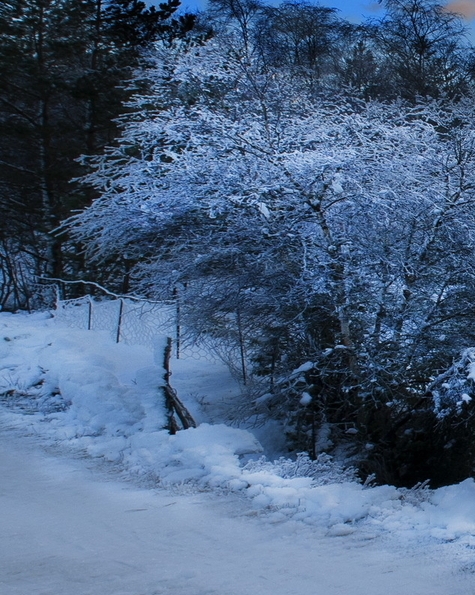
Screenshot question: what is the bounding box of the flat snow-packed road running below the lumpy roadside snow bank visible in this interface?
[0,433,475,595]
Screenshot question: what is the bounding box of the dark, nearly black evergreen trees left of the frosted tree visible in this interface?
[0,0,194,309]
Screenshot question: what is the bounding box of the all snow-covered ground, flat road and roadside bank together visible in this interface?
[0,314,475,595]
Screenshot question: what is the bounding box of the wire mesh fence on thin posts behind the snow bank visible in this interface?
[27,278,253,385]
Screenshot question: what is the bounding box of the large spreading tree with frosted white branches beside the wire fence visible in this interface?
[68,26,475,483]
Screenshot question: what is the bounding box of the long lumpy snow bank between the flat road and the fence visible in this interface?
[0,314,475,547]
